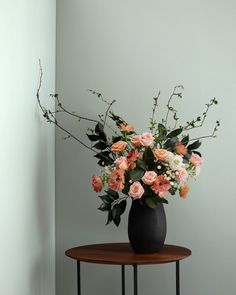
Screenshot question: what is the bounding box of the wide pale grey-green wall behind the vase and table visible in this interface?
[56,0,236,295]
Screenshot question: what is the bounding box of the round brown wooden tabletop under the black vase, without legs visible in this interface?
[65,243,191,265]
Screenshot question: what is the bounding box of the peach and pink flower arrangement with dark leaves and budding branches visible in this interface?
[37,69,220,226]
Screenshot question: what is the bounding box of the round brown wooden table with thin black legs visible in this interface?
[65,243,191,295]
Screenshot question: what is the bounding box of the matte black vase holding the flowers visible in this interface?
[128,200,166,253]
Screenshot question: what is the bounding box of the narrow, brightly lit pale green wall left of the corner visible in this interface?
[0,0,56,295]
